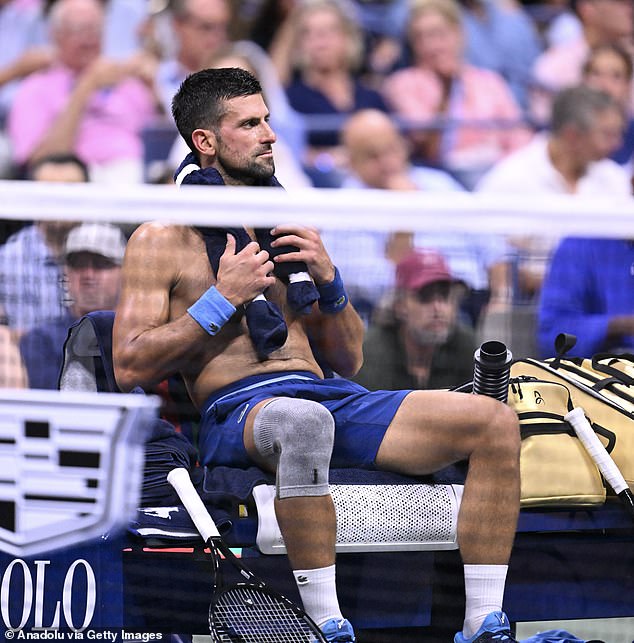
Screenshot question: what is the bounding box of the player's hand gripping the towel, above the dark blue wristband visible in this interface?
[271,223,335,285]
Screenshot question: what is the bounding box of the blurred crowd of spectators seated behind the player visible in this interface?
[0,0,634,388]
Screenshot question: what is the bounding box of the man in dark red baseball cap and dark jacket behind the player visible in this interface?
[354,249,475,390]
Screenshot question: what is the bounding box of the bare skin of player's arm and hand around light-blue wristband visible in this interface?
[113,224,275,391]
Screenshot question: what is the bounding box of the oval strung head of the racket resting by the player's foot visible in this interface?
[209,587,323,643]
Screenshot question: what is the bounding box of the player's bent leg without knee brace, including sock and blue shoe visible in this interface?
[377,391,520,643]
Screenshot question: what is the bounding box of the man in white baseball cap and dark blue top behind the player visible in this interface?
[20,223,126,389]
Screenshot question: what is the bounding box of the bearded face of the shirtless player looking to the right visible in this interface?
[214,94,276,185]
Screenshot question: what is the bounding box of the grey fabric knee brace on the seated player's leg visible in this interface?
[253,397,335,498]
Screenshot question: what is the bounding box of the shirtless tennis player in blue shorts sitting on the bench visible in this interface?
[114,68,520,643]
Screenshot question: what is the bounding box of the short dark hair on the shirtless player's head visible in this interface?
[172,67,262,152]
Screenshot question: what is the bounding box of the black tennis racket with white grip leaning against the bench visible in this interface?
[167,468,326,643]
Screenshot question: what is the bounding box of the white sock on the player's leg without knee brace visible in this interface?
[462,565,508,638]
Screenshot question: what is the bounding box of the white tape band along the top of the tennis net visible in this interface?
[0,181,634,238]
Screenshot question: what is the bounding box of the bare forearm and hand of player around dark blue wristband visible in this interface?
[271,223,364,377]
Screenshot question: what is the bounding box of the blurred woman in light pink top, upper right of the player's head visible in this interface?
[383,0,532,188]
